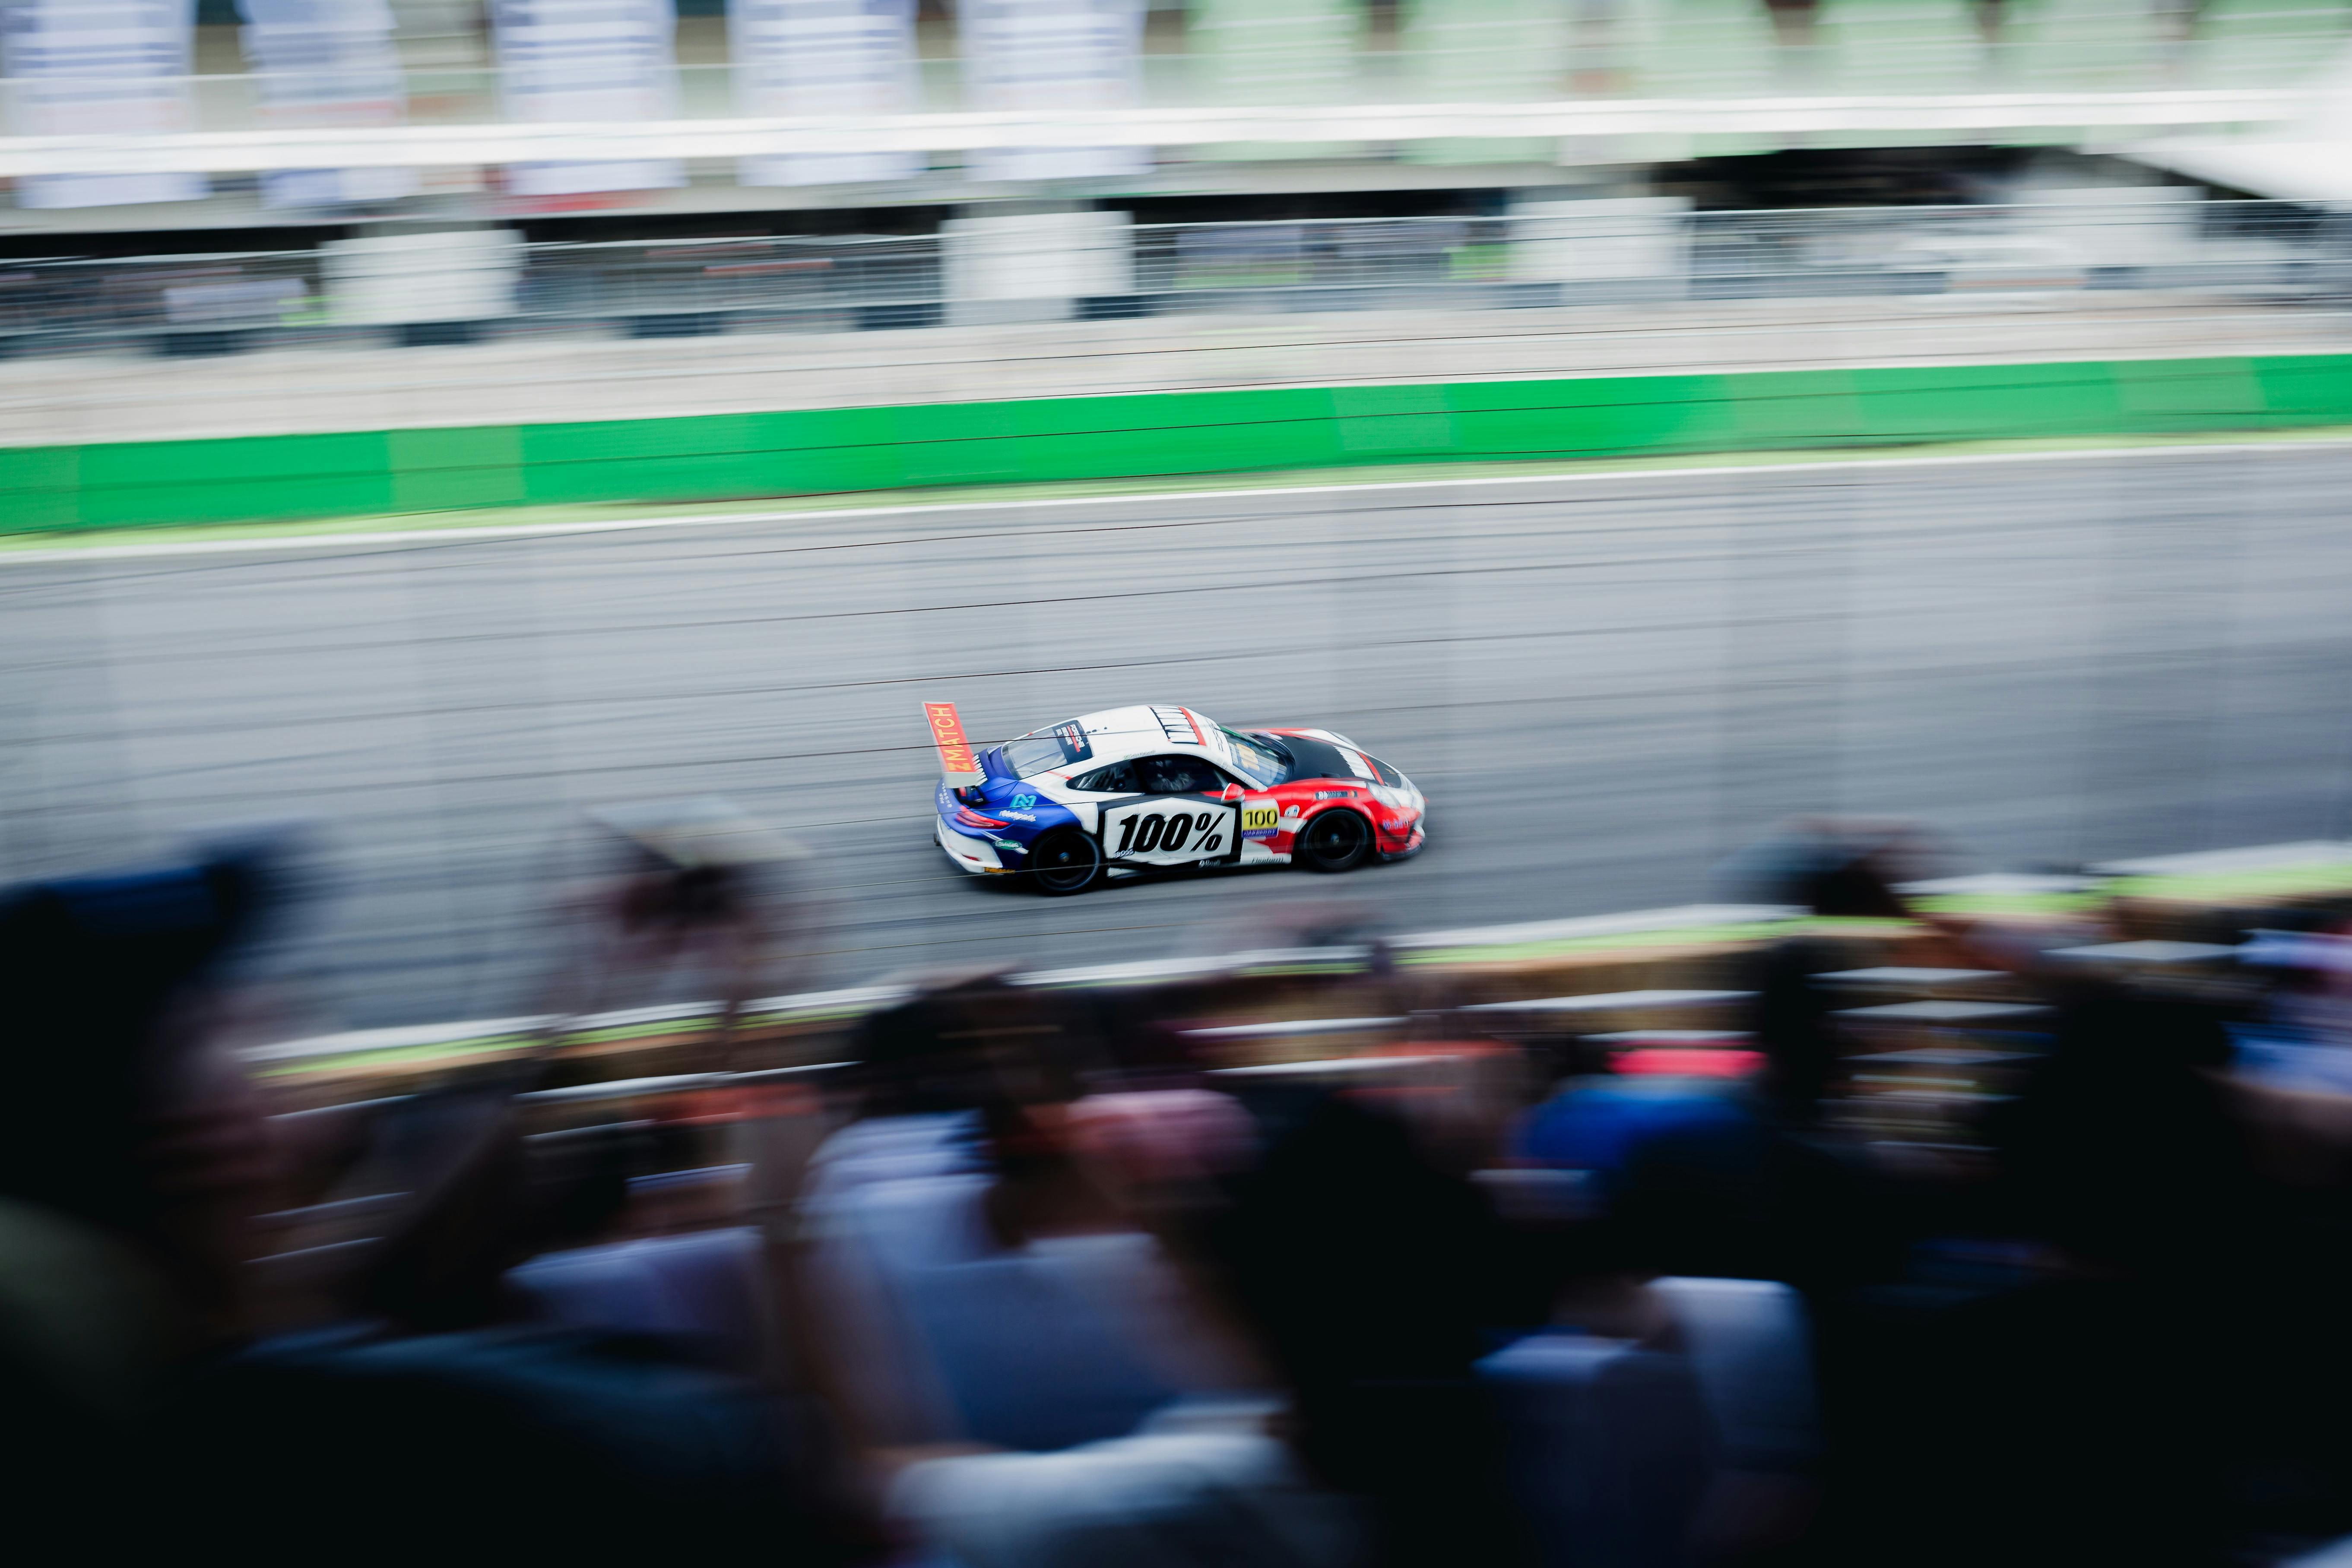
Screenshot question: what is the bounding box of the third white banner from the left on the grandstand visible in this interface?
[489,0,687,195]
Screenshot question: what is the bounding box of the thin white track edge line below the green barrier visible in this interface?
[0,437,2352,567]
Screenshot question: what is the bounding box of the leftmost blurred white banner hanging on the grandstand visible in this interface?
[0,0,212,207]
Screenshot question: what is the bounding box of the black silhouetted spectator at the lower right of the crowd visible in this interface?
[1929,987,2277,1563]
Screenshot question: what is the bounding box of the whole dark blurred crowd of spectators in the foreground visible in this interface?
[13,825,2352,1568]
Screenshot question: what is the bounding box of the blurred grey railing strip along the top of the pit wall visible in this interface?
[0,193,2352,353]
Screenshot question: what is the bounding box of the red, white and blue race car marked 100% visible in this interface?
[922,703,1428,896]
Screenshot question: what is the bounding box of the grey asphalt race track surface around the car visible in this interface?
[0,444,2352,1027]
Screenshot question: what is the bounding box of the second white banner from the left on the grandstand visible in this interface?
[240,0,416,207]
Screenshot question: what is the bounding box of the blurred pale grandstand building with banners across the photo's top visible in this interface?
[0,0,2352,256]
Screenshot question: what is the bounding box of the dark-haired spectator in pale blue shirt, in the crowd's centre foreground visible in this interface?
[802,978,1355,1568]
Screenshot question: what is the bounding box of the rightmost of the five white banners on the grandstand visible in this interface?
[960,0,1153,181]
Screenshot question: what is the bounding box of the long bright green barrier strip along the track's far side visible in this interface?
[0,355,2352,534]
